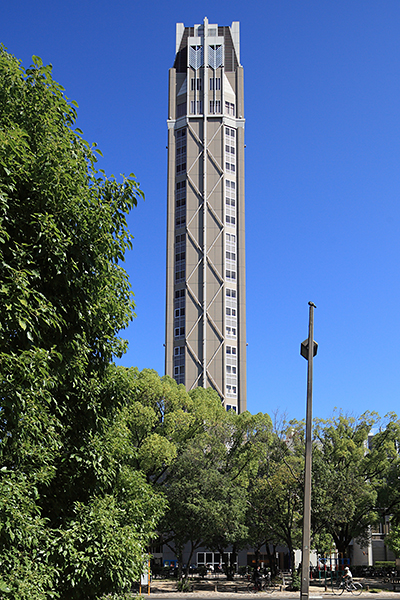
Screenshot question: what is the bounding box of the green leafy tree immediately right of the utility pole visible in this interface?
[312,413,386,557]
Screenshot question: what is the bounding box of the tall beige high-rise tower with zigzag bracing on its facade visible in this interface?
[165,19,246,412]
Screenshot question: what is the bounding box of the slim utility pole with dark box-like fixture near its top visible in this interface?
[300,302,318,600]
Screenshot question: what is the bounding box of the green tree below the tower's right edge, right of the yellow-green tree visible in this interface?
[159,406,270,576]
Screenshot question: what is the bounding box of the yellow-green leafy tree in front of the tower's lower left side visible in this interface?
[99,367,234,577]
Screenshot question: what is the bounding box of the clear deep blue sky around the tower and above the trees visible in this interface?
[0,0,400,418]
